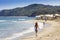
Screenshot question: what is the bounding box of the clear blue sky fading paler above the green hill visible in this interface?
[0,0,60,10]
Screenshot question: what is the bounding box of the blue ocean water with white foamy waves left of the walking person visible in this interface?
[0,16,35,40]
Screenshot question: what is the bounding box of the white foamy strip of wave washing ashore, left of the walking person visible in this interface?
[5,27,34,40]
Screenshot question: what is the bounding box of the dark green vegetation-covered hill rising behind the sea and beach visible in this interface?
[0,4,60,16]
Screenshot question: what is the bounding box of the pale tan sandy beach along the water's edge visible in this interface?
[19,19,60,40]
